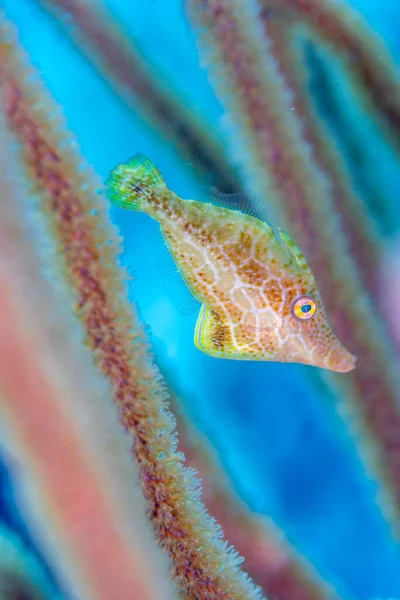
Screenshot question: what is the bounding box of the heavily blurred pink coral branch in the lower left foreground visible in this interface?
[0,117,174,600]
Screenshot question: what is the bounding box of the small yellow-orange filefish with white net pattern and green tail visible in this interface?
[108,154,356,373]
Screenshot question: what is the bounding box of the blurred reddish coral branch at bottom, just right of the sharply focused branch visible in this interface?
[173,411,339,600]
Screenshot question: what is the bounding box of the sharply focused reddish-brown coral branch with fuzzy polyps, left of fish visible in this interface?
[0,10,260,600]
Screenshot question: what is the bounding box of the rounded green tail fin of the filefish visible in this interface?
[107,154,167,210]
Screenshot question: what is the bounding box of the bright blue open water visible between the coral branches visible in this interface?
[0,0,400,600]
